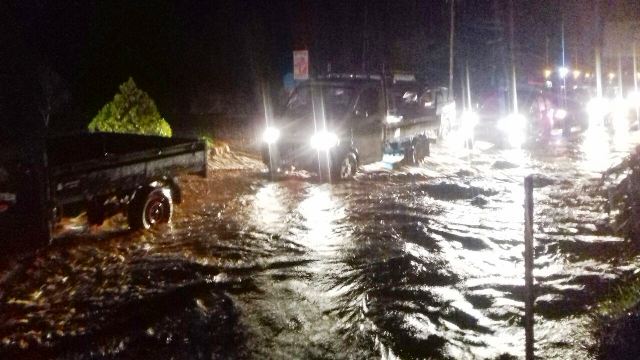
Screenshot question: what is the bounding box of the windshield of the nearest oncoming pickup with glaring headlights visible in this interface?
[287,85,354,117]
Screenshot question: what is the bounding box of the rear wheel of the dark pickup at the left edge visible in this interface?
[128,188,173,230]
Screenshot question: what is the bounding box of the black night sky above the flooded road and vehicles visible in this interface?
[0,0,640,132]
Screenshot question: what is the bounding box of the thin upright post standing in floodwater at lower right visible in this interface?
[524,175,535,360]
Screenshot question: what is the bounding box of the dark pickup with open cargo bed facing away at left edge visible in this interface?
[0,133,207,245]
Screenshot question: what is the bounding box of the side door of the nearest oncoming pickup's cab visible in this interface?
[351,86,384,164]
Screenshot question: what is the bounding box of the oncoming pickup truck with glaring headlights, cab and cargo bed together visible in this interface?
[262,74,455,181]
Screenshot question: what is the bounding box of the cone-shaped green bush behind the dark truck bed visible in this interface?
[88,78,171,137]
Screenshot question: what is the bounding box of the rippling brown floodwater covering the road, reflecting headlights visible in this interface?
[0,122,640,359]
